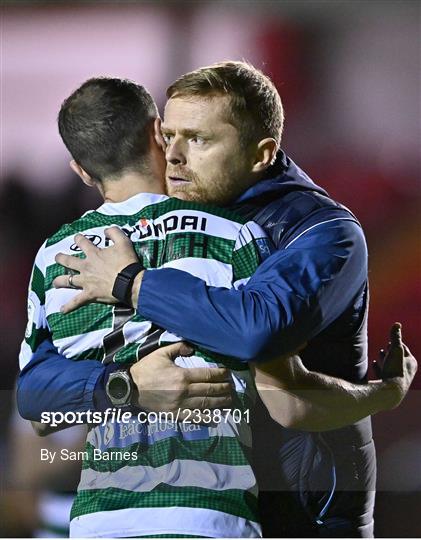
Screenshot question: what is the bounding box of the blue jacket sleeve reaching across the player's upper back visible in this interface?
[138,219,367,361]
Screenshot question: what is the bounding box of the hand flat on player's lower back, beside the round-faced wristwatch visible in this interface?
[130,343,232,414]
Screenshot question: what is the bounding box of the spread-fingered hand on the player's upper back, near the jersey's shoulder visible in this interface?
[53,227,140,313]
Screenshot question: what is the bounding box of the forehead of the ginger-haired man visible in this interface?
[163,94,231,129]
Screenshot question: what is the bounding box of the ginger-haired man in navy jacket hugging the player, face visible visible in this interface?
[20,62,411,536]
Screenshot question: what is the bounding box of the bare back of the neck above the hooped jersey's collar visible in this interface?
[98,172,164,202]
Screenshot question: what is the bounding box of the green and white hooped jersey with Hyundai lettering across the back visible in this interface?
[20,193,269,537]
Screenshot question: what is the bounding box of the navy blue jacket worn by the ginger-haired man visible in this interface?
[17,152,367,420]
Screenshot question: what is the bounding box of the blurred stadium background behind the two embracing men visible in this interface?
[0,0,421,537]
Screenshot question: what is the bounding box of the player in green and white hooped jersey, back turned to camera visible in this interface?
[20,78,271,538]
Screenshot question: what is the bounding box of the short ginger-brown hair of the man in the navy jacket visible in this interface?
[167,61,284,147]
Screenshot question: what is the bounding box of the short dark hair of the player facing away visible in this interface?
[58,77,158,180]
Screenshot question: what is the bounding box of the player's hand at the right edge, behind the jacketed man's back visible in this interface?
[375,323,418,409]
